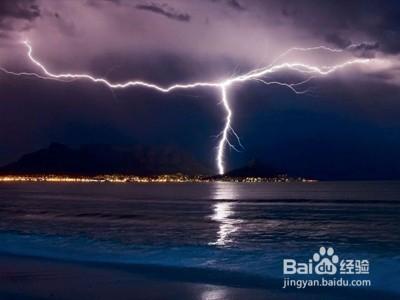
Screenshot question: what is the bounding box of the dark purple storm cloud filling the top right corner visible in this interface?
[276,0,400,56]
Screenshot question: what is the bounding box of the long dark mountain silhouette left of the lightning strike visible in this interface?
[0,143,211,176]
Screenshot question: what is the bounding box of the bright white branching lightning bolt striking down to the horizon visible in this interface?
[0,41,371,175]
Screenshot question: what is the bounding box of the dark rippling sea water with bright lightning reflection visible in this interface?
[0,182,400,294]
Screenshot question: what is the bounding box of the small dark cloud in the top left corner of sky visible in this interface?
[0,0,40,30]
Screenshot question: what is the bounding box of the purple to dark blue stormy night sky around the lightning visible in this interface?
[0,0,400,179]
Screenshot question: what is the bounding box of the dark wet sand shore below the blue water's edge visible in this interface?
[0,253,398,300]
